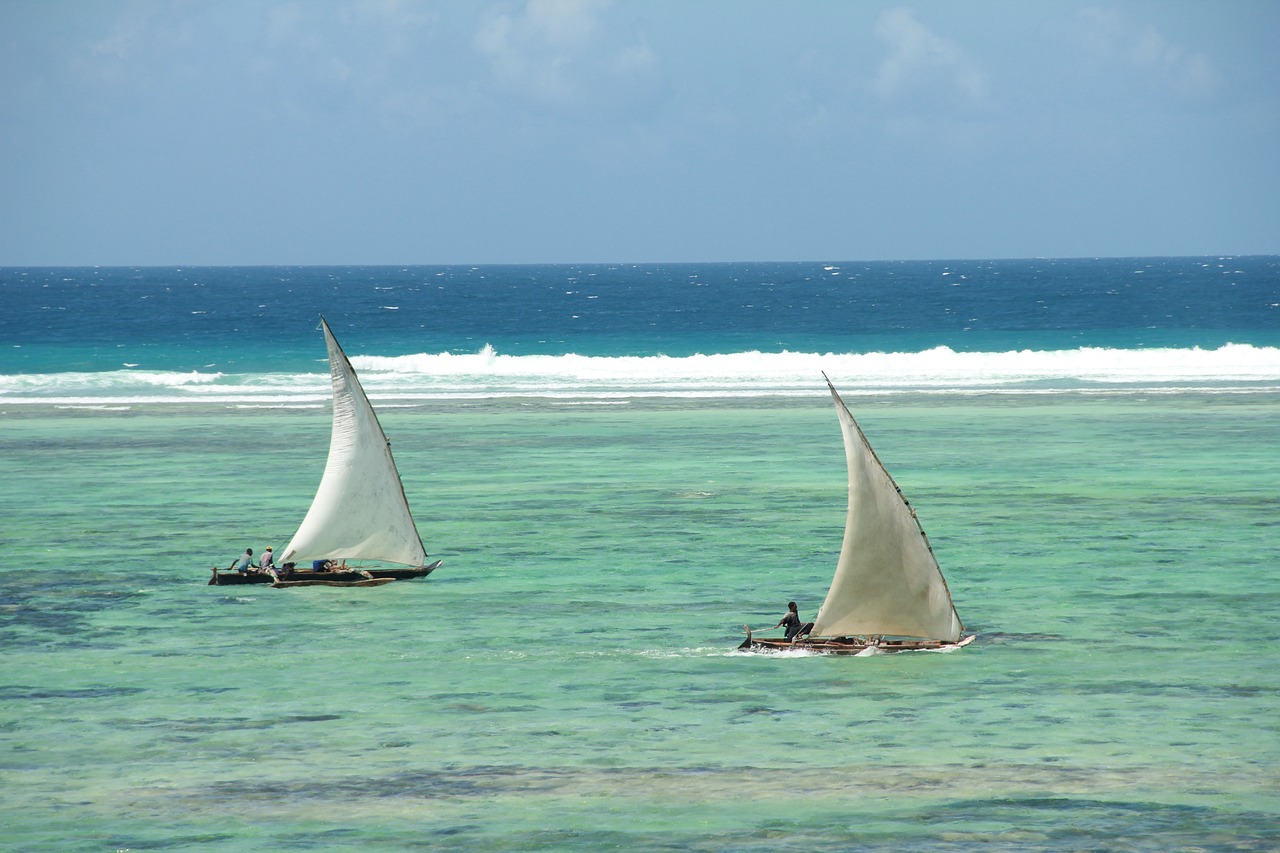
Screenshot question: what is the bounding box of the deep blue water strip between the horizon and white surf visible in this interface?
[0,256,1280,374]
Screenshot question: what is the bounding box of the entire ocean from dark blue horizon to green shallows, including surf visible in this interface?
[0,256,1280,852]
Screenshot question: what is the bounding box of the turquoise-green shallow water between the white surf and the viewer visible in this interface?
[0,393,1280,850]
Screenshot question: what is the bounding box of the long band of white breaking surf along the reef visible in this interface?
[0,345,1280,406]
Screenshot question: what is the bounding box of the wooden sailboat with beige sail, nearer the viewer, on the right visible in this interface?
[739,374,973,654]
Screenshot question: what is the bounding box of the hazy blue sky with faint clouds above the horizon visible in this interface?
[0,0,1280,266]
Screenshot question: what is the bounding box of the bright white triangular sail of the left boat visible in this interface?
[280,318,426,567]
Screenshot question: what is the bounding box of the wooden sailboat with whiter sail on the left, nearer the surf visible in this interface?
[209,318,442,587]
